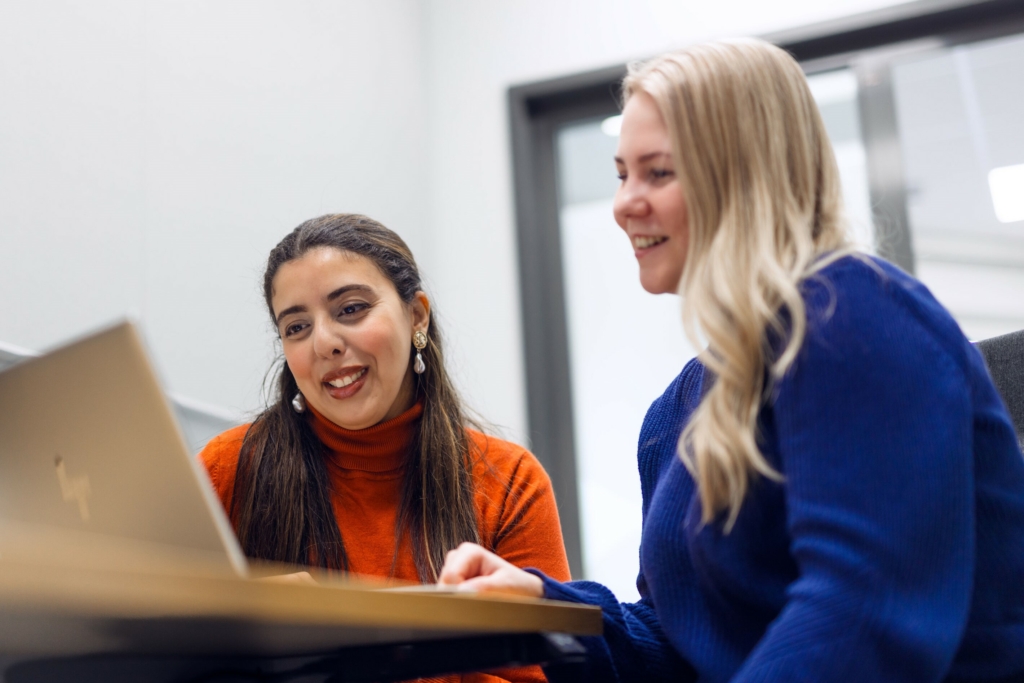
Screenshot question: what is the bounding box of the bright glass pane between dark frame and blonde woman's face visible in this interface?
[556,119,693,601]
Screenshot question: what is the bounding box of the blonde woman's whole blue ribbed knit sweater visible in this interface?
[542,257,1024,683]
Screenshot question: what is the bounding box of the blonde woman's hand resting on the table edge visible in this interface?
[437,543,544,598]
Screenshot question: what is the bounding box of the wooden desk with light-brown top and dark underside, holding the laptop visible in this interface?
[0,558,601,683]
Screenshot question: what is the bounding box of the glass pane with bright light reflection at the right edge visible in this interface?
[893,36,1024,339]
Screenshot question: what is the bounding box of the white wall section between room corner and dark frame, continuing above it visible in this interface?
[421,0,917,444]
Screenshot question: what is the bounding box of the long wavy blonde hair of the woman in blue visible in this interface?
[624,39,852,531]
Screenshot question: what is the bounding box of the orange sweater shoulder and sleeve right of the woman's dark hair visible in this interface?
[467,429,569,581]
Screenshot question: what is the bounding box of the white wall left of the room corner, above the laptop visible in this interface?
[0,0,426,411]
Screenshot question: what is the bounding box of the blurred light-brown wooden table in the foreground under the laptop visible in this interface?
[0,553,601,683]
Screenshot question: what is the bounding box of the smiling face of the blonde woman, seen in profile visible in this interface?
[612,91,688,294]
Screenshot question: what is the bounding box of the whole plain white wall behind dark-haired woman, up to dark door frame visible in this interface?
[0,0,913,438]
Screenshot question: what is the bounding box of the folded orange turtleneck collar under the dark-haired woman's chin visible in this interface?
[308,400,423,472]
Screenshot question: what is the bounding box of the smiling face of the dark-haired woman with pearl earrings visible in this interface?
[271,247,430,429]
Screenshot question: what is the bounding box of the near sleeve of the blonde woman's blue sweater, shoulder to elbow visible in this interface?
[733,269,975,683]
